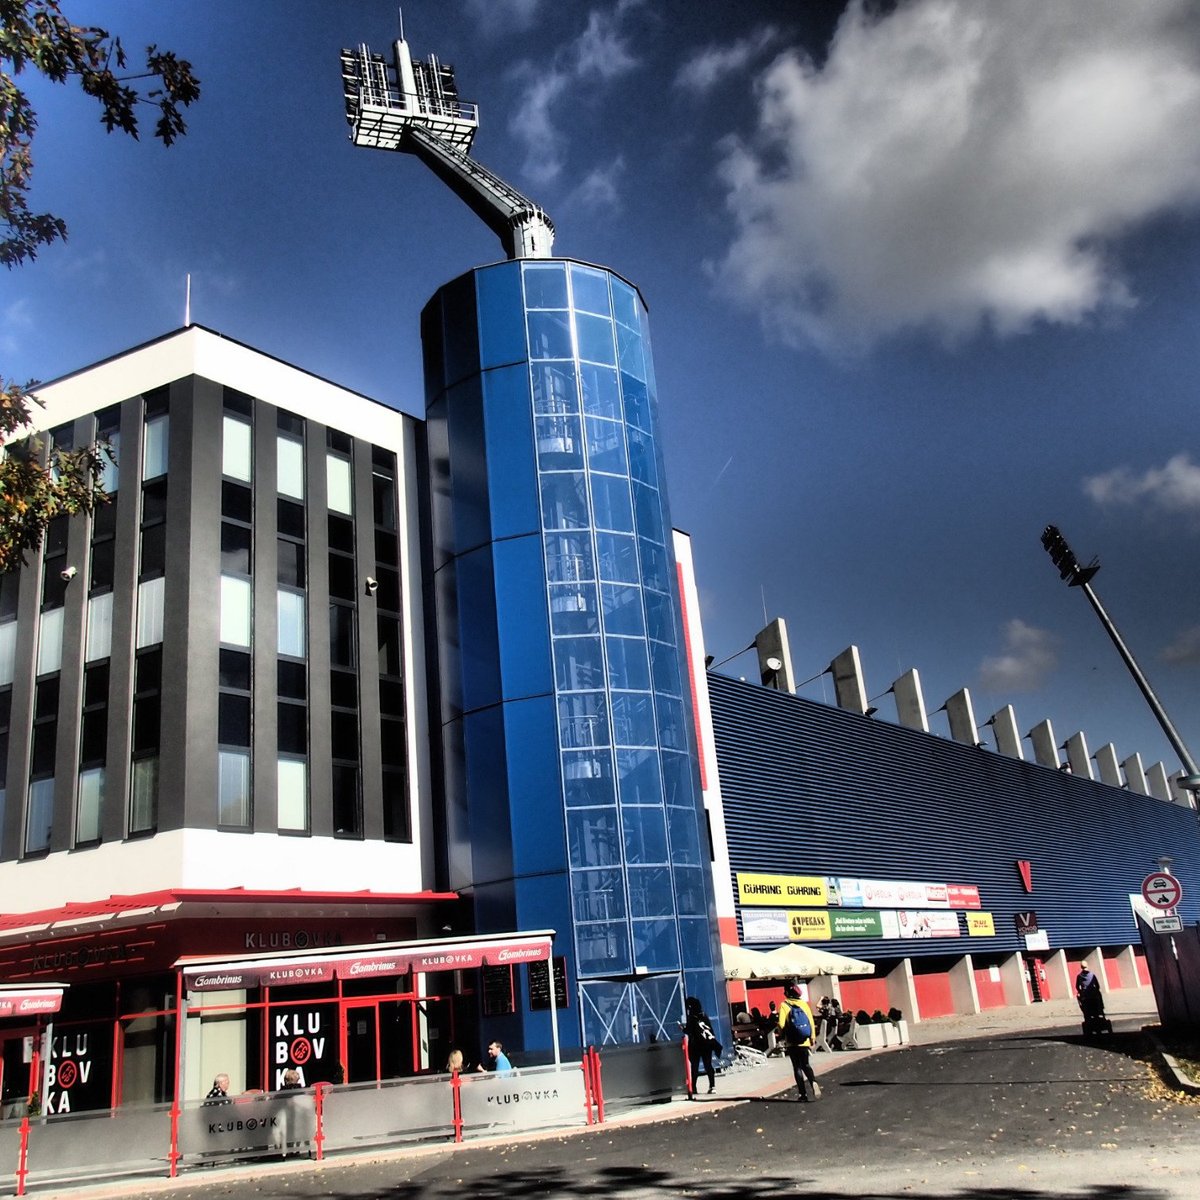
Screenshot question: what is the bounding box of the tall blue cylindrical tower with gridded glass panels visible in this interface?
[422,259,725,1048]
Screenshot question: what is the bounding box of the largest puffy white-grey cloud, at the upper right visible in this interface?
[714,0,1200,348]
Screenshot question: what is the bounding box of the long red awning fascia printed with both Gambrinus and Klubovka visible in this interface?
[175,931,554,991]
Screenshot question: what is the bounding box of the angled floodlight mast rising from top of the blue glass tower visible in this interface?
[342,28,554,258]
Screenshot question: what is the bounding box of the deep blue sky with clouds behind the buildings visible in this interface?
[7,0,1200,796]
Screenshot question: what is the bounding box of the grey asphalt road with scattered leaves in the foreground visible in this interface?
[105,1025,1200,1200]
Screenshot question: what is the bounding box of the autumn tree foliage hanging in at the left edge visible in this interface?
[0,0,200,571]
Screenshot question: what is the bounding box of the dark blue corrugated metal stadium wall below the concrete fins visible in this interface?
[708,674,1200,966]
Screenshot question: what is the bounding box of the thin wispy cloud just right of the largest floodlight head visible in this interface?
[509,0,642,184]
